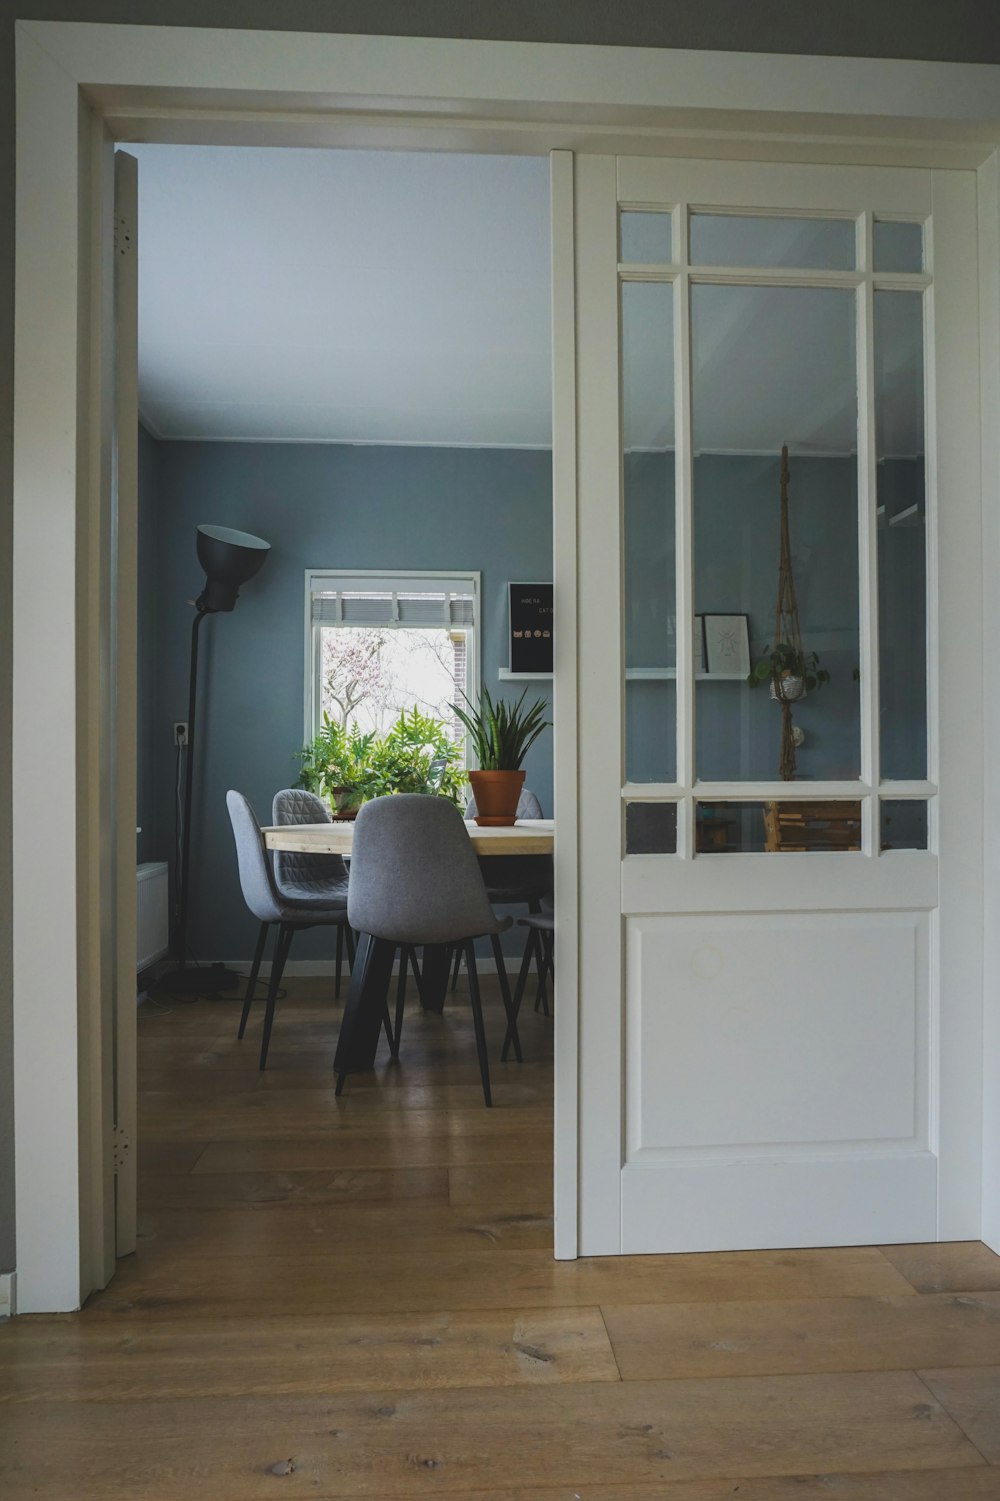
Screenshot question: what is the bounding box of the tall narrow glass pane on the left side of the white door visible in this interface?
[622,282,677,782]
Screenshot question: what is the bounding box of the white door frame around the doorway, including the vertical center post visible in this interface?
[14,21,1000,1312]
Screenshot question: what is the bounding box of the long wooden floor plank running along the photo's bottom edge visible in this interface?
[0,1372,979,1501]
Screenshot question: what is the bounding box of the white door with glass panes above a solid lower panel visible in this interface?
[575,156,982,1255]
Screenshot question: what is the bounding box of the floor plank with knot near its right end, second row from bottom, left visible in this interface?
[0,1309,619,1398]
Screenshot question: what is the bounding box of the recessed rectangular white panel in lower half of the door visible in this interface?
[626,913,928,1163]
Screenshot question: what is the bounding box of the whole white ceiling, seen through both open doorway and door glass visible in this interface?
[131,146,922,455]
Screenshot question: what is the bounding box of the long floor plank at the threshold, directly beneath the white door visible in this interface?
[87,1225,916,1318]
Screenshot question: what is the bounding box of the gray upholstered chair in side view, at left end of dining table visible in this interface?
[225,791,395,1069]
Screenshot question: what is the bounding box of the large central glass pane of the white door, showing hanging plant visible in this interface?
[691,282,860,781]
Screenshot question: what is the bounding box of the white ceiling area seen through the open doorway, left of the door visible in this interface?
[129,146,551,447]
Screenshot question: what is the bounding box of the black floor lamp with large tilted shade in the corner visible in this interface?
[153,525,270,995]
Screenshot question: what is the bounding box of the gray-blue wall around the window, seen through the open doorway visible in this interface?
[137,432,553,959]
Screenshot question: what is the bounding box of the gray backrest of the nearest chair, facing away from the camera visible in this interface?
[347,793,500,944]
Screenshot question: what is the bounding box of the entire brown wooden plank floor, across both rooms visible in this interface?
[0,980,1000,1501]
